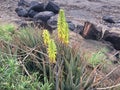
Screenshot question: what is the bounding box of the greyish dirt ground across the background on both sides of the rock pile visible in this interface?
[0,0,120,27]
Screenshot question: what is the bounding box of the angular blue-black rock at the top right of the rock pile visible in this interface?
[45,1,60,14]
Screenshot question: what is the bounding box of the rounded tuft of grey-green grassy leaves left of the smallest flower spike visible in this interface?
[14,27,43,48]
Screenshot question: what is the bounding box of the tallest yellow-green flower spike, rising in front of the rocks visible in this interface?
[57,9,69,44]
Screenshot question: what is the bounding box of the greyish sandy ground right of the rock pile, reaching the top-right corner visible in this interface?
[55,0,120,28]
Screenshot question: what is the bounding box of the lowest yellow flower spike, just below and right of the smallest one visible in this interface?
[47,39,57,63]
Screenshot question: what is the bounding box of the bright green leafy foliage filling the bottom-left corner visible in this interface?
[0,44,52,90]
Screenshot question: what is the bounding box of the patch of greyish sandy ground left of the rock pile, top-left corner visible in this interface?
[0,0,19,22]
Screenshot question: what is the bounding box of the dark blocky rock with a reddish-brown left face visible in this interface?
[81,22,102,40]
